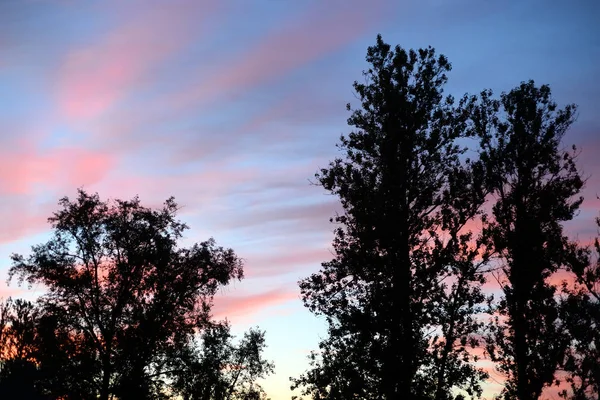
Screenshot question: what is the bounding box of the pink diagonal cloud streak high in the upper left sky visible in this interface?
[58,1,218,121]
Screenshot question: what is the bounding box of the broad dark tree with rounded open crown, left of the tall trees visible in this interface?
[4,190,272,400]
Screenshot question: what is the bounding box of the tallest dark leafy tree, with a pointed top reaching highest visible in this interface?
[292,36,485,399]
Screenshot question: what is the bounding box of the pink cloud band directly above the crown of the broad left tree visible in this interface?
[0,157,257,244]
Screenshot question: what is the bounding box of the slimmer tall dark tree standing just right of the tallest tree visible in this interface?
[473,81,583,400]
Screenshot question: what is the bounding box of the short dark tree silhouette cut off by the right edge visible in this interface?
[561,208,600,400]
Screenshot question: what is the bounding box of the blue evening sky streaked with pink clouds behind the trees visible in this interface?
[0,0,600,400]
